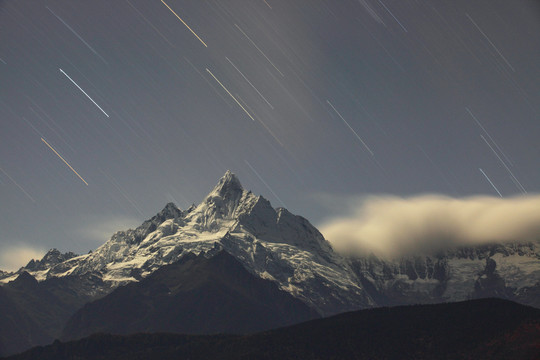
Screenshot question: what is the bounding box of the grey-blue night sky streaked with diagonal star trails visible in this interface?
[0,0,540,268]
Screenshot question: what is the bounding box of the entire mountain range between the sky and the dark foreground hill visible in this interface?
[0,172,540,355]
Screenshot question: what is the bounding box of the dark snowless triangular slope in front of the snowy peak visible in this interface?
[62,251,317,339]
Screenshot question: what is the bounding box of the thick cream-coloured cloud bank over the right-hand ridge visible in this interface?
[319,195,540,257]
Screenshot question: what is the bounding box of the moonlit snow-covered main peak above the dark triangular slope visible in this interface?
[5,171,375,314]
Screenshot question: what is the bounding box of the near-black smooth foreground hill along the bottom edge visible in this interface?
[7,299,540,360]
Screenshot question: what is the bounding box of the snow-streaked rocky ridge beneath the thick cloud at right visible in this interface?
[351,242,540,307]
